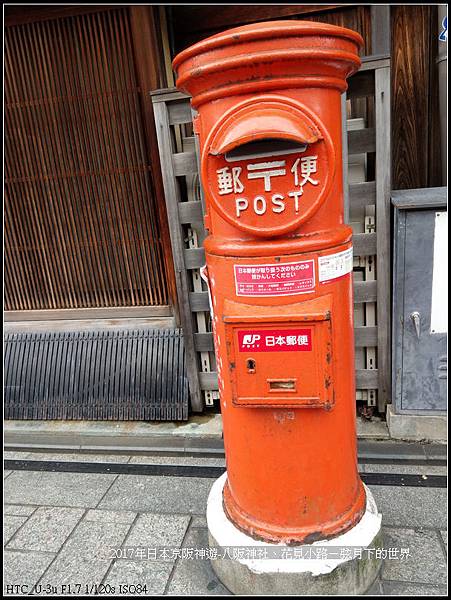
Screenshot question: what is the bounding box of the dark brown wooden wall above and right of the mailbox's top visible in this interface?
[168,4,442,189]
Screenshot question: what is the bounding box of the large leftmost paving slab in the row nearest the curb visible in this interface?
[4,471,117,508]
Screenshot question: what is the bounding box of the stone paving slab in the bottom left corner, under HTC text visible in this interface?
[3,550,55,593]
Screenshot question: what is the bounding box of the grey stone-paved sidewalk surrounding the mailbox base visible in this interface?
[4,452,447,596]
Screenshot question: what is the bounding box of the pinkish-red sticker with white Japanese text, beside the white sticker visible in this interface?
[234,260,315,296]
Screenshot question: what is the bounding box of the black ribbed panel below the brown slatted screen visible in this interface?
[4,329,188,421]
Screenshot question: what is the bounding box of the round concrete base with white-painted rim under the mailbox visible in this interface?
[207,473,382,596]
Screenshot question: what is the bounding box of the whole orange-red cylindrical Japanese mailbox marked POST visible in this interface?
[174,21,365,543]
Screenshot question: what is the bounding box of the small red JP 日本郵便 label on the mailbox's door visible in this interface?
[238,329,312,352]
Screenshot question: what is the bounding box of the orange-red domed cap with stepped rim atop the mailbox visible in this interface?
[172,21,363,107]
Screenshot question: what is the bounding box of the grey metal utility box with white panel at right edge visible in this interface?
[392,188,448,416]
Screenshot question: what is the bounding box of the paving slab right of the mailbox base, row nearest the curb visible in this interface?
[369,485,447,529]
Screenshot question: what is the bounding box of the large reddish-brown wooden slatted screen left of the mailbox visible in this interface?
[4,8,172,311]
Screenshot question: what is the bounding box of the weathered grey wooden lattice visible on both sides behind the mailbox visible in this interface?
[152,56,390,411]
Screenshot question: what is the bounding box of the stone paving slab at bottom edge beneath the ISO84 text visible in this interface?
[103,560,173,596]
